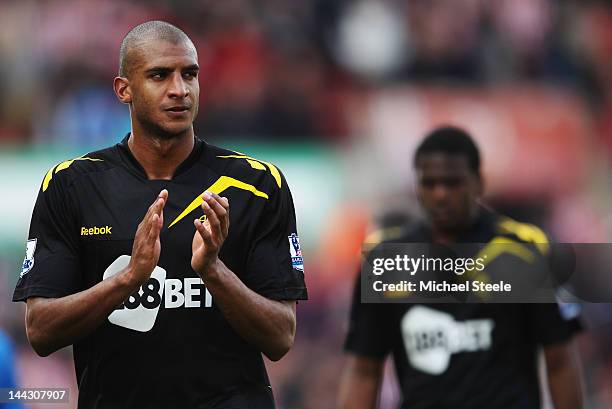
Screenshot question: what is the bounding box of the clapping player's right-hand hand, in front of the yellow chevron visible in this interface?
[191,192,229,278]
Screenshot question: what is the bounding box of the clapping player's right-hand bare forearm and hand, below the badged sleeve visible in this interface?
[191,193,296,361]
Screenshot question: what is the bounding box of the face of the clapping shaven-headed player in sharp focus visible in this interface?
[128,40,200,138]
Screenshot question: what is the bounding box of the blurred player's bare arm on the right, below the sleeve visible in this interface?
[544,341,583,409]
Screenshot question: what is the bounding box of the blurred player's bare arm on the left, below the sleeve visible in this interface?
[338,355,384,409]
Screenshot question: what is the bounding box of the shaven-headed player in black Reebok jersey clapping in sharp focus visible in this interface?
[13,21,307,409]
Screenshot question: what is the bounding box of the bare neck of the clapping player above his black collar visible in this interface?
[128,127,194,180]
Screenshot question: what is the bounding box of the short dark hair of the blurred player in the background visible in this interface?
[414,126,480,174]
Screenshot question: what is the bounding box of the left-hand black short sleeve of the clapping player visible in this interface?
[13,167,80,301]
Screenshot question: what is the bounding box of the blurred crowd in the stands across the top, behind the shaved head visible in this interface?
[0,0,612,149]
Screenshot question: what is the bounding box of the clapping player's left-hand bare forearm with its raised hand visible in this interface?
[26,190,168,356]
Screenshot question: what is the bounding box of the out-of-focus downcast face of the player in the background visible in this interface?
[416,152,482,231]
